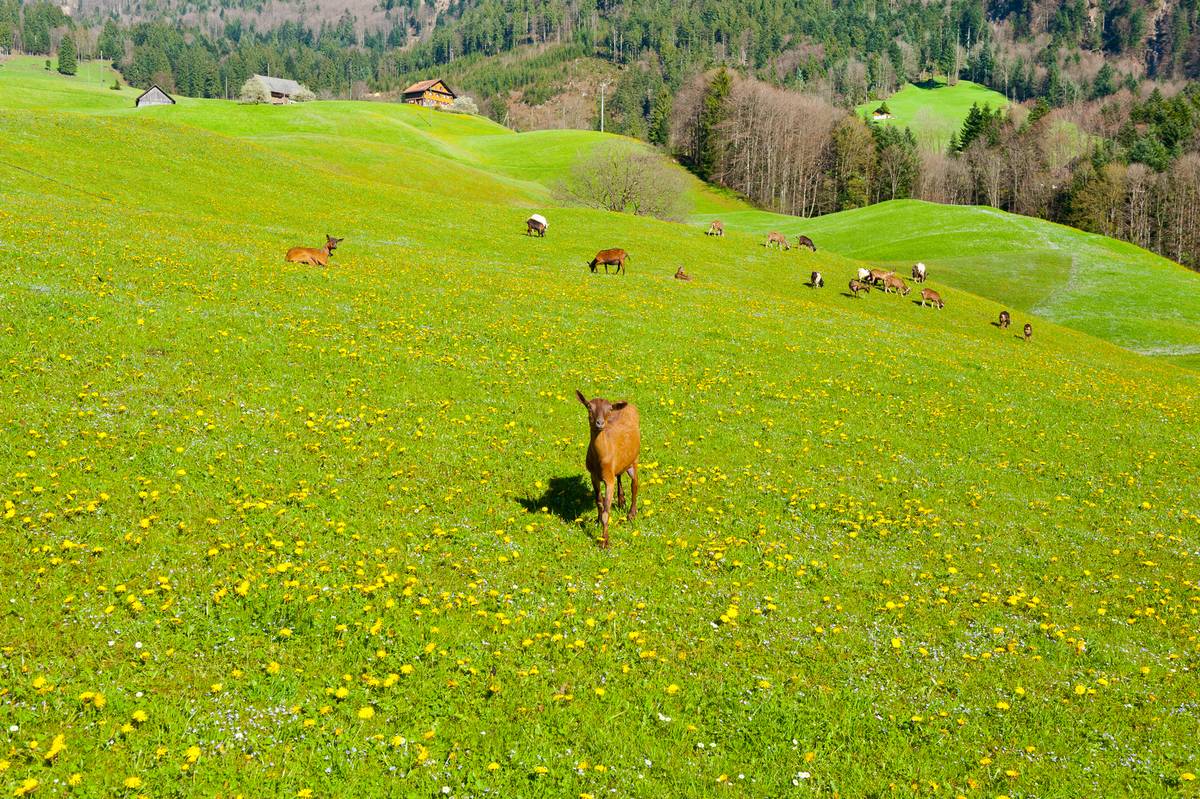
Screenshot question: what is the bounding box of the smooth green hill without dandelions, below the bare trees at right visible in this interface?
[695,200,1200,366]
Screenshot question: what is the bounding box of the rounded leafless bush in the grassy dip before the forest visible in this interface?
[559,142,688,220]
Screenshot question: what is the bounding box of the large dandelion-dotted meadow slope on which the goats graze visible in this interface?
[0,60,1200,799]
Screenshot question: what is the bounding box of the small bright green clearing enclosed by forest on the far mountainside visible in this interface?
[854,78,1008,151]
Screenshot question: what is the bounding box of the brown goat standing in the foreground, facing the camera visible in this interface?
[575,389,642,549]
